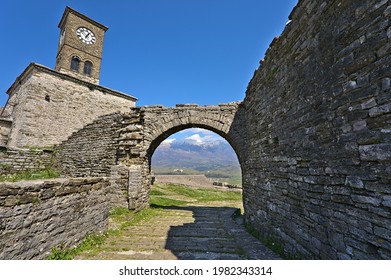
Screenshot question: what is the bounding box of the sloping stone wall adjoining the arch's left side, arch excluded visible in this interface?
[54,113,129,207]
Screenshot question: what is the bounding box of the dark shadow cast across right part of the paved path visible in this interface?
[154,203,280,260]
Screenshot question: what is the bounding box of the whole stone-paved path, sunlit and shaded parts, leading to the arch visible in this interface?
[79,205,279,260]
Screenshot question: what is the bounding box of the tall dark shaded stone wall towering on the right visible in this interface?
[242,0,391,259]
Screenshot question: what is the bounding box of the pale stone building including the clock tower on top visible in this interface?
[0,7,137,148]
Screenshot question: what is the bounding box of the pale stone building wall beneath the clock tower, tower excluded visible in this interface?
[5,64,136,147]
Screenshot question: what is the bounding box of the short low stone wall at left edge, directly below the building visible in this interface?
[0,146,53,175]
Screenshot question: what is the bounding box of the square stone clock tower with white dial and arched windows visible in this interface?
[55,7,108,84]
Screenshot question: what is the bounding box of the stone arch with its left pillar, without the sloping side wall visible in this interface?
[118,103,246,209]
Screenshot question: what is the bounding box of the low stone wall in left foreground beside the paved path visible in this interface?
[0,178,110,259]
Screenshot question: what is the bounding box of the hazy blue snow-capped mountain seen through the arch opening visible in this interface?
[152,137,239,172]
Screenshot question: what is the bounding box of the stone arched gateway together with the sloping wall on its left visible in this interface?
[57,102,246,209]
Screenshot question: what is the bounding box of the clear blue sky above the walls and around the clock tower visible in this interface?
[0,0,297,106]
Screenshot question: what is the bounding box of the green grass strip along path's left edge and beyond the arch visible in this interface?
[48,184,242,260]
